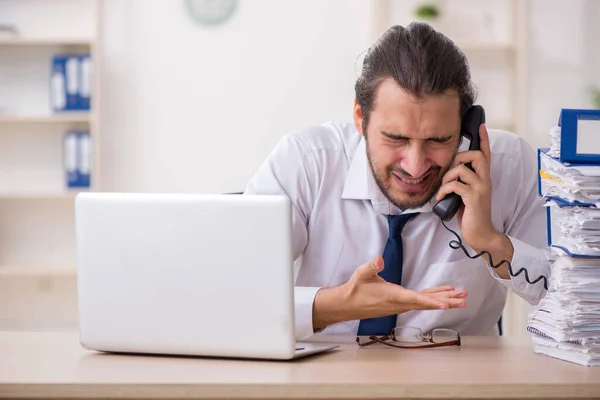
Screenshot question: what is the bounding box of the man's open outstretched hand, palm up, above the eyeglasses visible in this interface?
[313,256,467,329]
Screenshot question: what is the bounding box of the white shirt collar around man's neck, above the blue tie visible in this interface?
[342,136,454,215]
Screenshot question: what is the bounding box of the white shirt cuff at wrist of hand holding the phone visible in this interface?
[486,235,550,305]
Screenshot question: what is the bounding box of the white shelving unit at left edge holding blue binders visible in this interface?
[0,0,102,329]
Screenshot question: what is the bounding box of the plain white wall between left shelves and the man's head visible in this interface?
[102,0,371,192]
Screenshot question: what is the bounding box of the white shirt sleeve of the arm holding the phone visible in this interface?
[488,140,551,305]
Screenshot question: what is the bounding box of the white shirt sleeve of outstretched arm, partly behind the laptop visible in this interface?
[244,133,320,340]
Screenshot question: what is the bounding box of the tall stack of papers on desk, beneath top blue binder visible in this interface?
[527,118,600,366]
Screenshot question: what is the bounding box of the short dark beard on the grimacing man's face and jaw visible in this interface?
[367,142,450,210]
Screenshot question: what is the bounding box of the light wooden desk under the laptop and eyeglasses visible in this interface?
[0,332,600,399]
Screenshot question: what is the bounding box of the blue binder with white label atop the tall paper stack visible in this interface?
[558,109,600,164]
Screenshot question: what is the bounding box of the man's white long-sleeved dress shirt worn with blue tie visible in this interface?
[245,122,549,340]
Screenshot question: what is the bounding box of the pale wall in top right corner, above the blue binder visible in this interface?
[527,0,600,147]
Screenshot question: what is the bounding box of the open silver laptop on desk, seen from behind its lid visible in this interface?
[75,193,337,360]
